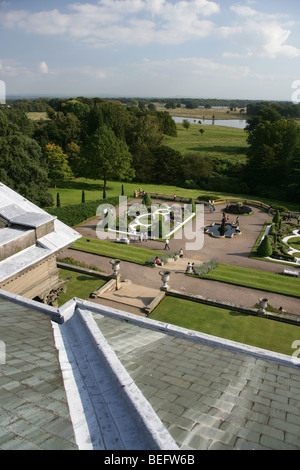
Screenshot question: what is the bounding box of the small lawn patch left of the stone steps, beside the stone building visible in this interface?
[58,269,105,306]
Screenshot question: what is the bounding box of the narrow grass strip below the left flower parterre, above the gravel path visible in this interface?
[71,237,165,265]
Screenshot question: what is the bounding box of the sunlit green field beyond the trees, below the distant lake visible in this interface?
[165,123,248,162]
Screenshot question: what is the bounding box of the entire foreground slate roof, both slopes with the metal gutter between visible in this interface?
[0,291,300,450]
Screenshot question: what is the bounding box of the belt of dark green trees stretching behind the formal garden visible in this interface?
[0,97,300,206]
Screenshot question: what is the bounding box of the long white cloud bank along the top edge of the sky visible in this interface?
[0,0,220,46]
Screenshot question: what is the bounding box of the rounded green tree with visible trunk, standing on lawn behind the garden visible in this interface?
[82,125,134,198]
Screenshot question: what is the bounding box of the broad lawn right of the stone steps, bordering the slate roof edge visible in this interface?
[150,297,300,355]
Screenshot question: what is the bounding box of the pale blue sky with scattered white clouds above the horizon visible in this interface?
[0,0,300,101]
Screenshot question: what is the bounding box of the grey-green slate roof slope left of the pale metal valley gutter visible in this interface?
[0,299,77,450]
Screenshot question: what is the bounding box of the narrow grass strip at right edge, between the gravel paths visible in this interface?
[201,264,300,297]
